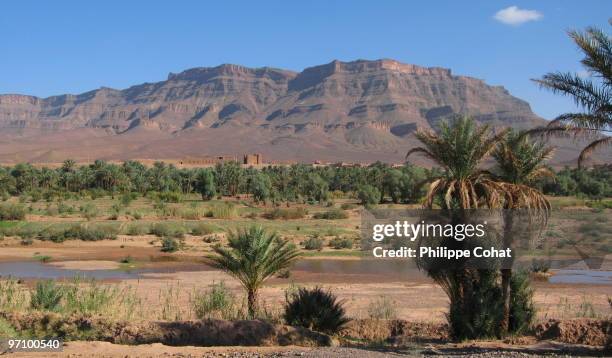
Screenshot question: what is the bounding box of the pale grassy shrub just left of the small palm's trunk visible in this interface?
[190,282,237,320]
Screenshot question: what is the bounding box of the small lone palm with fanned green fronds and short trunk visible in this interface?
[210,226,300,318]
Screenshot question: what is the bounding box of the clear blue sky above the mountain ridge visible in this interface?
[0,0,612,118]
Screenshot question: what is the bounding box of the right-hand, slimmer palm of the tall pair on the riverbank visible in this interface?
[492,131,554,332]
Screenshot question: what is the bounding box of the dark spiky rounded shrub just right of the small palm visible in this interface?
[284,287,349,334]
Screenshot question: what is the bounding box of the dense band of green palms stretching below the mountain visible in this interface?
[0,160,612,204]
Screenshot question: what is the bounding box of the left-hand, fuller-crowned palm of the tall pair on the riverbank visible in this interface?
[406,117,507,338]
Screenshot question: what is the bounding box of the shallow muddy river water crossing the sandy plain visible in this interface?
[0,259,612,285]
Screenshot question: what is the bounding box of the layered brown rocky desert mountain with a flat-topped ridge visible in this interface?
[0,60,592,162]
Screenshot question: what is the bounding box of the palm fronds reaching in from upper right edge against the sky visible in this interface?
[530,20,612,167]
